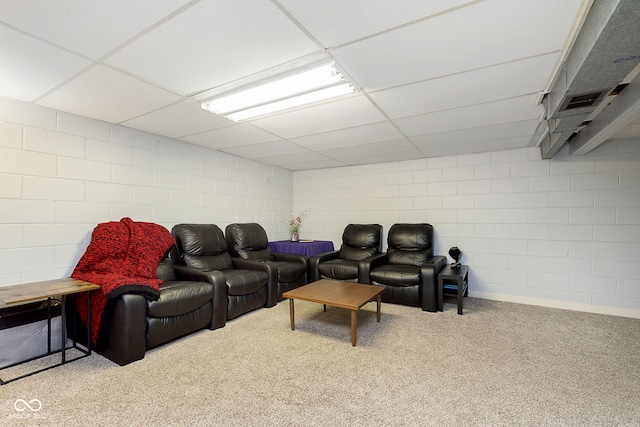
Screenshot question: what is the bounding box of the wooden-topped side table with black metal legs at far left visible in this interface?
[0,278,100,385]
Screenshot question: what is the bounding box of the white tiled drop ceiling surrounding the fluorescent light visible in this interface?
[0,0,640,170]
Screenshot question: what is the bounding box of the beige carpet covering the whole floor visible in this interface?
[0,298,640,426]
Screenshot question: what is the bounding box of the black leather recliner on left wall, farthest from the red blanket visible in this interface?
[225,223,309,301]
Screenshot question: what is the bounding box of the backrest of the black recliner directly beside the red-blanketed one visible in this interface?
[171,224,233,270]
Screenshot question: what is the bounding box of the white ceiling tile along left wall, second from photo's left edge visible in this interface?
[37,65,179,124]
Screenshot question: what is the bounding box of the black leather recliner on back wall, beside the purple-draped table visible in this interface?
[309,224,382,284]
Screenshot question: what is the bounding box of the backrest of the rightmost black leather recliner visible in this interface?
[387,224,433,266]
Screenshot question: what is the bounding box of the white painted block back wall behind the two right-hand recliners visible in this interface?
[293,140,640,317]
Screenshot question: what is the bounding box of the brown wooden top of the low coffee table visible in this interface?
[282,279,385,310]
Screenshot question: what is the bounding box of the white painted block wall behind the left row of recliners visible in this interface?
[0,98,293,286]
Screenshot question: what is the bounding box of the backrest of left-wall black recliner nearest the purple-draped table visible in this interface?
[224,222,273,261]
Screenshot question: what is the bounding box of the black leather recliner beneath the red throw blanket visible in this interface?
[94,247,226,365]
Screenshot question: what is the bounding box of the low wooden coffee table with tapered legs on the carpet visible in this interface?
[282,279,385,346]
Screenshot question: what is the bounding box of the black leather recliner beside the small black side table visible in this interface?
[369,224,447,312]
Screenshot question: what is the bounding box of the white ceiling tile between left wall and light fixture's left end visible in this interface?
[122,100,232,138]
